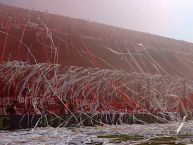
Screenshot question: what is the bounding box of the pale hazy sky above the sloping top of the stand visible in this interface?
[0,0,193,42]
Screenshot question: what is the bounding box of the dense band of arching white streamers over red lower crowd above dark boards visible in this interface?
[0,61,193,124]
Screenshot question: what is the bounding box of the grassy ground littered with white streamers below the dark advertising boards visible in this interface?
[0,121,193,145]
